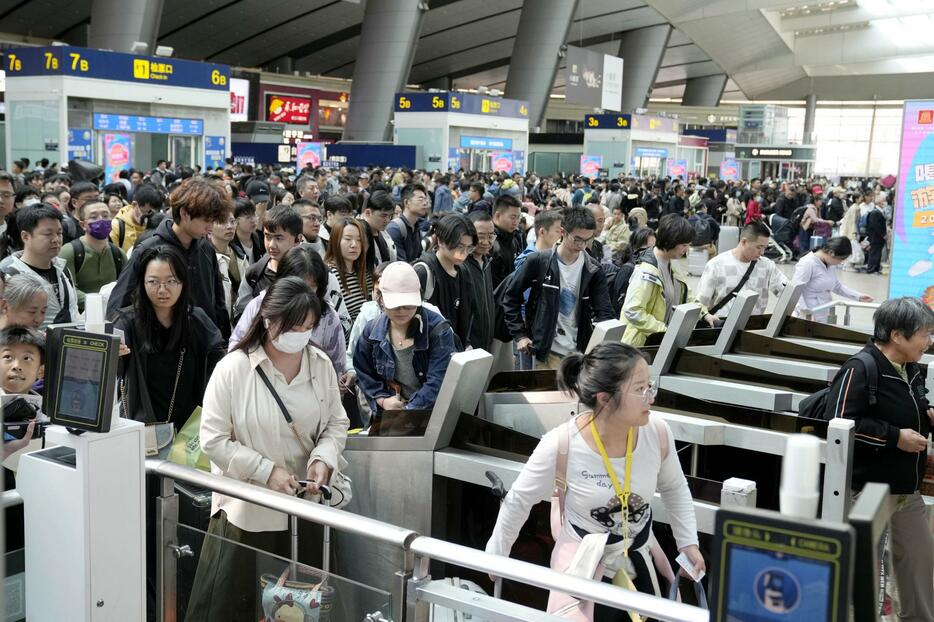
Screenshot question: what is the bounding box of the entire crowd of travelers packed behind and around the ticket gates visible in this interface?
[0,160,934,620]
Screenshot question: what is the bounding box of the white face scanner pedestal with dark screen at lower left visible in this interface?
[16,328,146,621]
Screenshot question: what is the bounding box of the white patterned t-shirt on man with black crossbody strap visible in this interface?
[697,251,788,317]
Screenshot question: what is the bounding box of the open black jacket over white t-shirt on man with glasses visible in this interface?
[503,250,614,361]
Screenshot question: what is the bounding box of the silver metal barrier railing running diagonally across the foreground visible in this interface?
[146,459,709,622]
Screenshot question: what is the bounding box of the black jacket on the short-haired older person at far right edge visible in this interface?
[825,342,931,495]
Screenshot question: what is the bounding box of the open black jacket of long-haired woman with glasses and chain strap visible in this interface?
[116,307,227,423]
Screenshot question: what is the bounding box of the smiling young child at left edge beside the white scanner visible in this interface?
[0,326,45,458]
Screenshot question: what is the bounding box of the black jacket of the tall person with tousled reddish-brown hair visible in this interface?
[107,218,230,339]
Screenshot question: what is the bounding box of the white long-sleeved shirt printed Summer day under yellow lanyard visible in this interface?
[486,414,697,555]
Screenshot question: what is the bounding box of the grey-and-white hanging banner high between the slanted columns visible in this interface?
[565,45,623,111]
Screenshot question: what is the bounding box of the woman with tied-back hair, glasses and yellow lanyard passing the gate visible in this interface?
[486,343,705,622]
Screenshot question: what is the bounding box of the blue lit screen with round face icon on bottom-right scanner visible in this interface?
[726,545,831,622]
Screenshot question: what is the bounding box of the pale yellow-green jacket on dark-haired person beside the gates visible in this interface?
[619,248,707,348]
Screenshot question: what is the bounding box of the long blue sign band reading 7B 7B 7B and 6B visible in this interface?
[4,45,230,91]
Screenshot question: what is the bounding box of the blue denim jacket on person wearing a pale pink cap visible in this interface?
[353,307,455,412]
